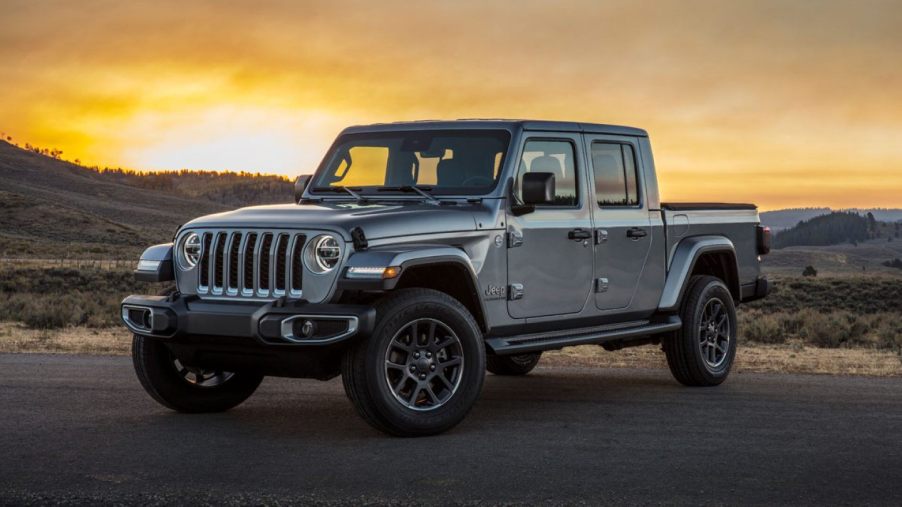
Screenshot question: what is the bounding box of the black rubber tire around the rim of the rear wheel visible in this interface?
[663,276,737,386]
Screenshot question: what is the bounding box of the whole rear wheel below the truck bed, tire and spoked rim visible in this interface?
[664,276,736,386]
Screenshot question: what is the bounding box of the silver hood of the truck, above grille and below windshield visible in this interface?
[185,201,487,240]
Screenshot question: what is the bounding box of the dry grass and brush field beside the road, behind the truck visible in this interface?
[0,261,902,375]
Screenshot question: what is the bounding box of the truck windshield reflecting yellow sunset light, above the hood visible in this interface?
[312,130,510,195]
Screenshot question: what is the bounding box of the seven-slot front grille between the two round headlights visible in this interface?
[197,230,306,297]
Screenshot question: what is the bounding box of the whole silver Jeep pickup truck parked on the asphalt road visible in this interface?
[121,120,770,436]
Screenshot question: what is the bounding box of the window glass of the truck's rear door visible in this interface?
[592,142,639,207]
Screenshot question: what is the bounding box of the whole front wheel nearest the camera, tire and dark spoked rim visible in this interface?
[342,289,485,436]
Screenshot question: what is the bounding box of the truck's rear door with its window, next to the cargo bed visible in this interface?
[586,135,653,310]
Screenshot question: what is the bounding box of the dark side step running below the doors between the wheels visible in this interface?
[485,315,682,355]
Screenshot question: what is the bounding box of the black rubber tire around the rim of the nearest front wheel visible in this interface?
[341,288,485,437]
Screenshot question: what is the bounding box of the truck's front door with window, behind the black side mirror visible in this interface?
[507,133,593,318]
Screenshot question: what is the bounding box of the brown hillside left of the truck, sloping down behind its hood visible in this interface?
[0,141,292,258]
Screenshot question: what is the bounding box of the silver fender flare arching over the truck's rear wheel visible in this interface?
[658,235,739,312]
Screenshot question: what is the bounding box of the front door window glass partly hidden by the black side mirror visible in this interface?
[516,141,579,206]
